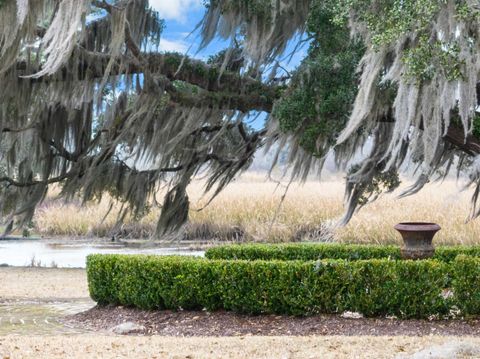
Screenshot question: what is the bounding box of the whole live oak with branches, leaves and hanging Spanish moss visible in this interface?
[0,0,480,239]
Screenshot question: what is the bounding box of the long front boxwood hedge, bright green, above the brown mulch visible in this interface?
[87,255,468,318]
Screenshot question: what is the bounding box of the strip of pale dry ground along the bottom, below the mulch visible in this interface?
[0,336,480,359]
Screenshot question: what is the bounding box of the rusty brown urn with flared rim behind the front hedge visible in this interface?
[394,222,441,259]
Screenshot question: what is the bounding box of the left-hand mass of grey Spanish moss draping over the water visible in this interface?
[0,0,261,239]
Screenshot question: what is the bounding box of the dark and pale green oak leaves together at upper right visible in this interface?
[273,0,480,157]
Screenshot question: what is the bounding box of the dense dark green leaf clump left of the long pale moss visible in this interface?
[273,1,364,157]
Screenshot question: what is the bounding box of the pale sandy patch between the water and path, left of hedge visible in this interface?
[0,267,88,300]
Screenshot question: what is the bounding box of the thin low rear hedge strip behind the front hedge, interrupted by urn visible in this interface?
[205,243,480,262]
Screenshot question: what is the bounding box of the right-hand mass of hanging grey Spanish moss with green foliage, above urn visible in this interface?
[208,0,480,224]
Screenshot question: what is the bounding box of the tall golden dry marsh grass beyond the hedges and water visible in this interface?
[31,175,480,244]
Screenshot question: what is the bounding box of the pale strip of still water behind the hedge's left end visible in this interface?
[0,239,203,268]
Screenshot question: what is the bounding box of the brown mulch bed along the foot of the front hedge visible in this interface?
[66,306,480,337]
